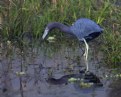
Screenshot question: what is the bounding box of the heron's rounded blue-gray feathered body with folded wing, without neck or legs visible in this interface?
[70,18,103,41]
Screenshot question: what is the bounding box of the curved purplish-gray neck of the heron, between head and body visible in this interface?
[47,22,73,34]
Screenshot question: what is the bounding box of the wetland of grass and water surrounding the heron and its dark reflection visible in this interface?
[0,0,121,97]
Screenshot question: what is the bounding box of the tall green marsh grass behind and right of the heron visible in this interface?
[0,0,121,66]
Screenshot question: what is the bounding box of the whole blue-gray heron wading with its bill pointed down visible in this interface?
[42,18,103,71]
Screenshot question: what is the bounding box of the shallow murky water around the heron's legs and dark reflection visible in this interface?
[0,39,120,97]
